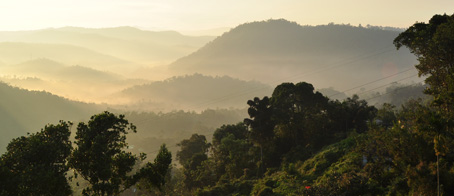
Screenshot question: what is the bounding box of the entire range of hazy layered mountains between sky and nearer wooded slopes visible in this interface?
[0,19,417,110]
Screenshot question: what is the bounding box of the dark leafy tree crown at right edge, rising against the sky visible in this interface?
[394,14,454,110]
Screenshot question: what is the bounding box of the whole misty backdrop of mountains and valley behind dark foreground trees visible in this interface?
[0,15,436,196]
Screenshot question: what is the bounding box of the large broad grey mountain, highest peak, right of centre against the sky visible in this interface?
[169,19,416,90]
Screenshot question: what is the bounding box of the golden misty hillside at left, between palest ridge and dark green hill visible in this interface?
[0,58,146,103]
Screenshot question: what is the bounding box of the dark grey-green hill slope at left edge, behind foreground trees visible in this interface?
[0,82,102,152]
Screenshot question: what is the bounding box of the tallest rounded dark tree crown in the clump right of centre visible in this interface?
[271,82,328,148]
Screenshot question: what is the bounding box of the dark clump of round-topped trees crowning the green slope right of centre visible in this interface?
[244,82,377,170]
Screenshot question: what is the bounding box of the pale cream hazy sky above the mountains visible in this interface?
[0,0,454,31]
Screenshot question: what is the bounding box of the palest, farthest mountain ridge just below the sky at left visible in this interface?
[0,27,214,65]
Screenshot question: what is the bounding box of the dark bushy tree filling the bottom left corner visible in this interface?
[0,121,72,195]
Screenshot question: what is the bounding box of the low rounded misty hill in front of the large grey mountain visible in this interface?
[117,74,272,111]
